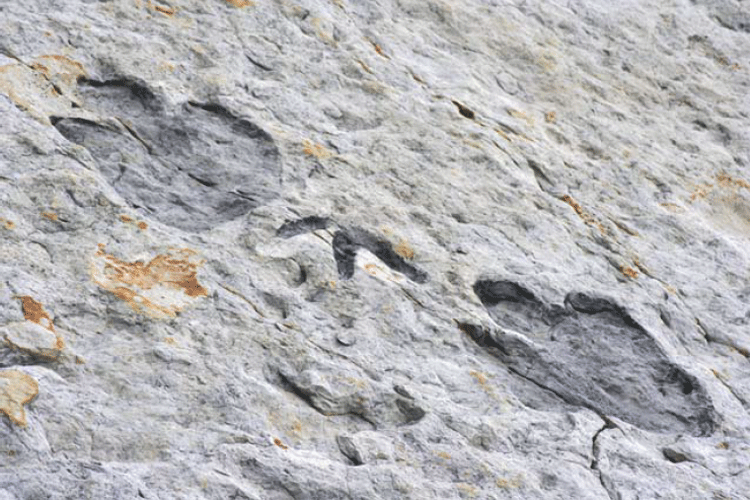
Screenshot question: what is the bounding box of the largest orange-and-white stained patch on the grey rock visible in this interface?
[91,245,208,318]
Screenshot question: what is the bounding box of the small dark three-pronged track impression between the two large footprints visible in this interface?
[276,216,428,283]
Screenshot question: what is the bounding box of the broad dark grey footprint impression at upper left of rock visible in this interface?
[52,80,281,231]
